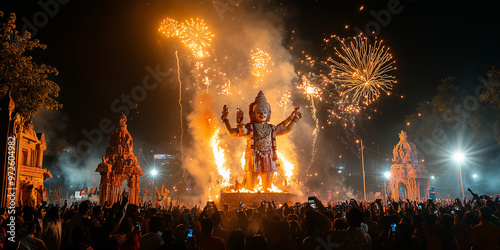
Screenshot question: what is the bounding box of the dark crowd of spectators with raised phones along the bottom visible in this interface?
[0,188,500,250]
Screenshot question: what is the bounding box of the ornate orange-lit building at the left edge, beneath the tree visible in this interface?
[0,93,52,207]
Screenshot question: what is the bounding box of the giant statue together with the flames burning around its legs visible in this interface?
[213,91,302,206]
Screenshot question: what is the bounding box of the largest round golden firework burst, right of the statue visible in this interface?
[328,35,397,106]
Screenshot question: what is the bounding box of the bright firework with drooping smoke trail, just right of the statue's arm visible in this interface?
[297,74,322,173]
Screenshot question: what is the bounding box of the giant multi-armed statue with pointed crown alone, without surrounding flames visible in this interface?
[221,91,302,191]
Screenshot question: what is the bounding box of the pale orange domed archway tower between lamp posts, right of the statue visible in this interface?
[390,131,429,201]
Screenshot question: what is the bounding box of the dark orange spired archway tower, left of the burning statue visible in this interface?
[95,113,142,204]
